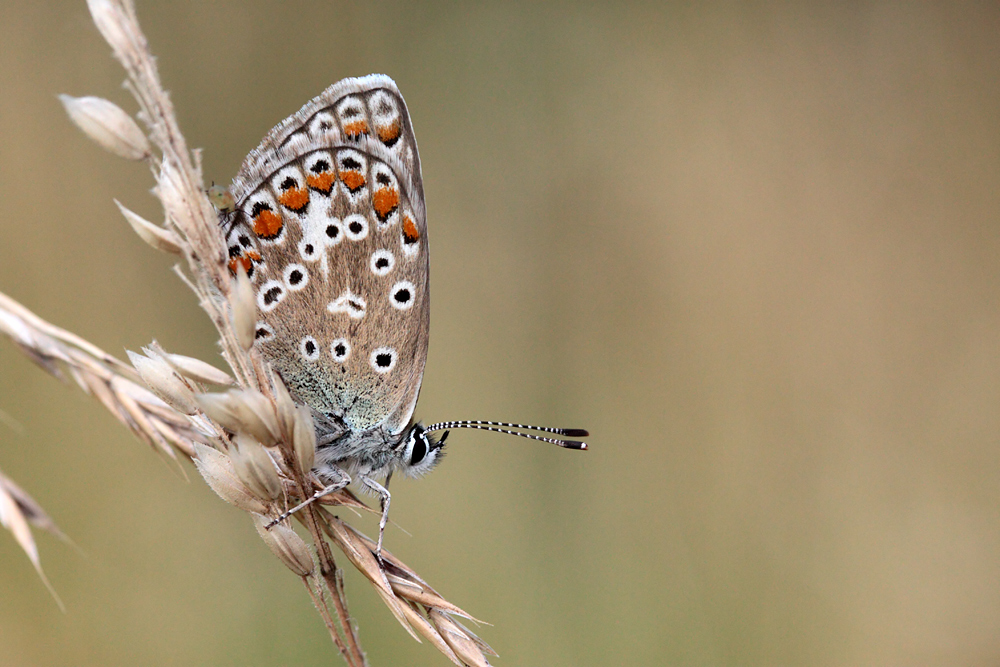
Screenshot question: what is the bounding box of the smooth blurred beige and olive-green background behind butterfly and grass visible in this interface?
[0,0,1000,666]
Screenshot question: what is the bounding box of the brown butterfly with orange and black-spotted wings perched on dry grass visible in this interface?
[210,74,588,557]
